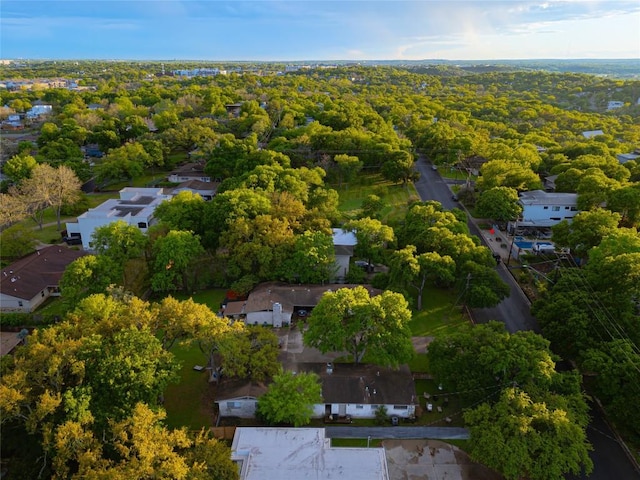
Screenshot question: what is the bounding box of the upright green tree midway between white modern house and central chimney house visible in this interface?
[151,230,204,292]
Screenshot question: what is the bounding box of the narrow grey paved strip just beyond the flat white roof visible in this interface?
[324,425,469,440]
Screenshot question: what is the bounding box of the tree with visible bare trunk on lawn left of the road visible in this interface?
[390,245,456,310]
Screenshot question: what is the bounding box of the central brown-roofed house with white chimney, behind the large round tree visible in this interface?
[223,282,379,328]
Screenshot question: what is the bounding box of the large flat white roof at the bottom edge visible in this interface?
[231,427,389,480]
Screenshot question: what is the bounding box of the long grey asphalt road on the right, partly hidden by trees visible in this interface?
[415,157,640,480]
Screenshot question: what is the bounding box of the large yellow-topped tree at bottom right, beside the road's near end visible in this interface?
[464,388,593,480]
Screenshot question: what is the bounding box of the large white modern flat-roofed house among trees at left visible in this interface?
[67,187,171,249]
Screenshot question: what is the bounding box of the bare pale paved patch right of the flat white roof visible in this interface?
[382,440,504,480]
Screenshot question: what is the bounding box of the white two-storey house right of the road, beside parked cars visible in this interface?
[518,190,578,227]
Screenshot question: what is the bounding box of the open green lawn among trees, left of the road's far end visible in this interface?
[332,173,417,223]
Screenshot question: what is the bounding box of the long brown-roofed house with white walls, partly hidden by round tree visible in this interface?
[215,363,419,422]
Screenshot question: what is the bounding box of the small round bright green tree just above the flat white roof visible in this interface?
[257,371,322,427]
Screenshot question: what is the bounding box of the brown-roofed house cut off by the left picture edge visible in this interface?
[0,245,85,312]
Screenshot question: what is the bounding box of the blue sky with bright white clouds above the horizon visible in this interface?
[0,0,640,62]
